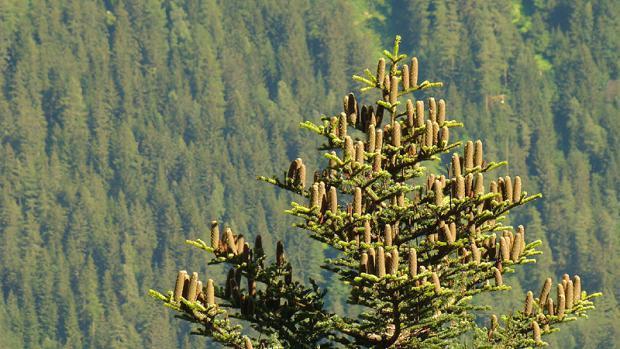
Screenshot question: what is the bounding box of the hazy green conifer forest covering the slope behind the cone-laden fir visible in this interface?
[0,0,620,348]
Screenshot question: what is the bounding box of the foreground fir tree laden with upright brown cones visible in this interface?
[151,37,600,348]
